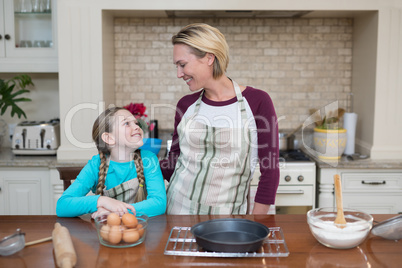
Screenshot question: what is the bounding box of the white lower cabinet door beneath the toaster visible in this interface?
[0,167,54,215]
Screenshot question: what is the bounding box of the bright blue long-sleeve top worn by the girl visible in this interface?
[56,150,166,217]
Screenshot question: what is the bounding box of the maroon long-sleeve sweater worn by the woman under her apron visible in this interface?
[160,87,279,204]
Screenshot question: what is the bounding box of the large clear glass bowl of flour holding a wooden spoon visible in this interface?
[307,207,373,249]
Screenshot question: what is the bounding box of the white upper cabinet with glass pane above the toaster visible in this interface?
[0,0,58,73]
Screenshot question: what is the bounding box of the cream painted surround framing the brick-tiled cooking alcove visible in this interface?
[57,0,402,160]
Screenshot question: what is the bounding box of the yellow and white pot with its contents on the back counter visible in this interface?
[313,108,347,160]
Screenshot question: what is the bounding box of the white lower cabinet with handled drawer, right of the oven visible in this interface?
[318,169,402,214]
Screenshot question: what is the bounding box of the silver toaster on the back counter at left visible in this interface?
[11,119,60,155]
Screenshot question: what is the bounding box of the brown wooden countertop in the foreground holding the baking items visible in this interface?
[0,215,402,268]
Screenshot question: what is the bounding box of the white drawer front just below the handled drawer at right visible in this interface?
[343,193,402,214]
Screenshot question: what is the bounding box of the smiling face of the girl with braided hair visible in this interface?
[109,110,144,149]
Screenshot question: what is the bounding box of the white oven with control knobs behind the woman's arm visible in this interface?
[248,150,316,214]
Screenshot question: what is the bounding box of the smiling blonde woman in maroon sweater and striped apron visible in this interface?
[161,24,279,214]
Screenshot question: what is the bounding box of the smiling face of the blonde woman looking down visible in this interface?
[173,44,215,91]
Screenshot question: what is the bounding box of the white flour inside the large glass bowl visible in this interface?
[310,221,371,248]
